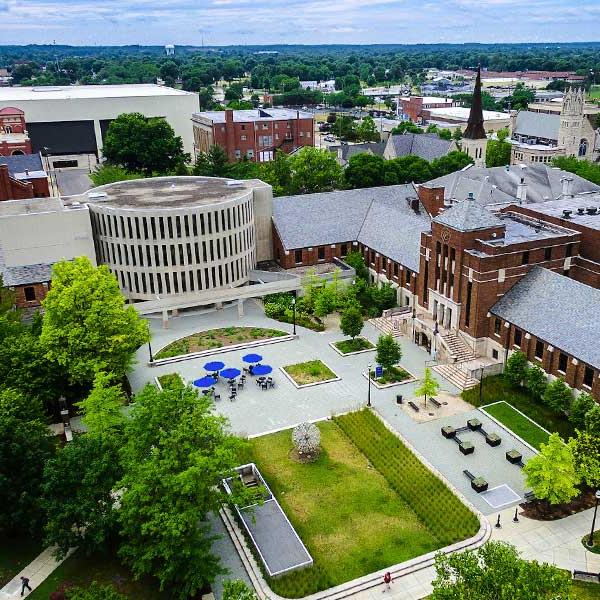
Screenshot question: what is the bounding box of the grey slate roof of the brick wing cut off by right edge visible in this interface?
[490,267,600,369]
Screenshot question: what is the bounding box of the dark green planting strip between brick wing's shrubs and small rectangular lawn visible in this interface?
[462,375,575,440]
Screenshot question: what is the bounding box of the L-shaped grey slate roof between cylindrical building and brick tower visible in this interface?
[273,185,431,272]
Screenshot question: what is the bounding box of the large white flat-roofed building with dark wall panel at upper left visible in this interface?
[0,84,199,166]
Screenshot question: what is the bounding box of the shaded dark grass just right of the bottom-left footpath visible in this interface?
[27,553,173,600]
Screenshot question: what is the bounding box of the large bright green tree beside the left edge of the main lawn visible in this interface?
[118,385,241,598]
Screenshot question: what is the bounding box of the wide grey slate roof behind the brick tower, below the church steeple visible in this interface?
[423,164,600,205]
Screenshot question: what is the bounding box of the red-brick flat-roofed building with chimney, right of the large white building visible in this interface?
[192,108,315,162]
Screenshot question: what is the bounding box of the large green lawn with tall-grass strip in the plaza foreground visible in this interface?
[245,413,478,598]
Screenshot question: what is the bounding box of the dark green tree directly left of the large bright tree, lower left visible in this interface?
[42,433,123,557]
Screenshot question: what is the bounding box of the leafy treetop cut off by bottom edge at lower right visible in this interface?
[431,542,571,600]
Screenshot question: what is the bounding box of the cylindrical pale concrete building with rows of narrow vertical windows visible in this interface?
[82,177,271,300]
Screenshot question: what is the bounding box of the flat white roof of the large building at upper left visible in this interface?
[0,83,195,102]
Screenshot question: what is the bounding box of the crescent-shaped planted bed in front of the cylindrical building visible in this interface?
[155,327,289,360]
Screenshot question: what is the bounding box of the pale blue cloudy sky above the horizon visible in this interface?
[0,0,600,45]
